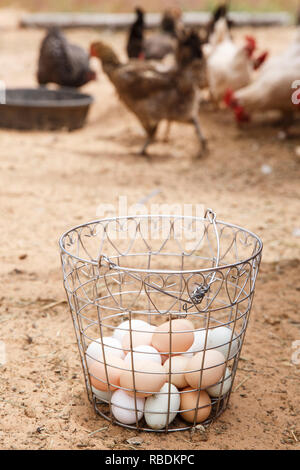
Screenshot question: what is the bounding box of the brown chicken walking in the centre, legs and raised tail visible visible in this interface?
[91,32,206,154]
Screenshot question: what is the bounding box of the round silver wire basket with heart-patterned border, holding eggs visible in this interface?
[60,210,262,432]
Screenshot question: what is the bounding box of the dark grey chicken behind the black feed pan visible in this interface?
[37,28,96,88]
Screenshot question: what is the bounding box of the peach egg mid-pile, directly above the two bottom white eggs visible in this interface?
[120,361,167,397]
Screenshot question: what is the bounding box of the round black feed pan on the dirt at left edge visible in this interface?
[0,88,93,131]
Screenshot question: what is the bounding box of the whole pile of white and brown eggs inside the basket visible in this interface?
[86,319,239,430]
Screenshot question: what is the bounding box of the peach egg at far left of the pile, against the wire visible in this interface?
[89,354,125,392]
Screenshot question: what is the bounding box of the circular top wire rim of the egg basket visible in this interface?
[59,214,263,274]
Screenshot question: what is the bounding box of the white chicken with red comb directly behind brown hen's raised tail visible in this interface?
[203,18,265,103]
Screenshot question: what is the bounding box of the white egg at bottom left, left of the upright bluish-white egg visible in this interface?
[111,390,145,424]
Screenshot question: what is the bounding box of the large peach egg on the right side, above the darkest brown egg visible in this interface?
[185,349,225,388]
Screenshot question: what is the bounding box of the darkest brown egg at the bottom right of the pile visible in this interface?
[180,387,211,423]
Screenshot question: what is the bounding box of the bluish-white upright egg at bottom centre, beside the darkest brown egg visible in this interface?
[144,383,180,429]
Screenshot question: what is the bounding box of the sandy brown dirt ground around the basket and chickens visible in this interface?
[0,11,300,450]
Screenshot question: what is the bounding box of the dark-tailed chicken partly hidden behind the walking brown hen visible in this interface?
[127,8,179,60]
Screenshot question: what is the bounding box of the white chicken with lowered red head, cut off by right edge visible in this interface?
[225,29,300,123]
